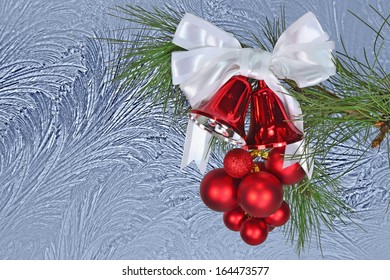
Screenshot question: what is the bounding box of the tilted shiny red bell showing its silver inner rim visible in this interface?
[190,76,252,145]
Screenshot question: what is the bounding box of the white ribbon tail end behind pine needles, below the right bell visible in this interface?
[283,140,314,179]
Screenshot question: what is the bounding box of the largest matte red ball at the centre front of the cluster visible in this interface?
[237,171,283,218]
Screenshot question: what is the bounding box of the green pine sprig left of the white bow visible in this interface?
[109,5,188,115]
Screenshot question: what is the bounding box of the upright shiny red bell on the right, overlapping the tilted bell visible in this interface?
[245,80,303,150]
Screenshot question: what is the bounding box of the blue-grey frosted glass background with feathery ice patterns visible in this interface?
[0,0,390,259]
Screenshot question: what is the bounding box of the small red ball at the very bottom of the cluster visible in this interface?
[240,218,268,246]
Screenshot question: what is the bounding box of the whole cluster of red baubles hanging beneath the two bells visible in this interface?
[200,148,305,245]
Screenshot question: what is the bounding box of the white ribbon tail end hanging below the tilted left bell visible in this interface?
[181,120,212,174]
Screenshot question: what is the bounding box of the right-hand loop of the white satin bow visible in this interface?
[271,12,336,87]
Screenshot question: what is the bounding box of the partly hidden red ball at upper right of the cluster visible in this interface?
[265,147,306,185]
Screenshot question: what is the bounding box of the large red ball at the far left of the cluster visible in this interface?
[200,168,239,212]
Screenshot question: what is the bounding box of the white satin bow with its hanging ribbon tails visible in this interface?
[172,12,336,178]
